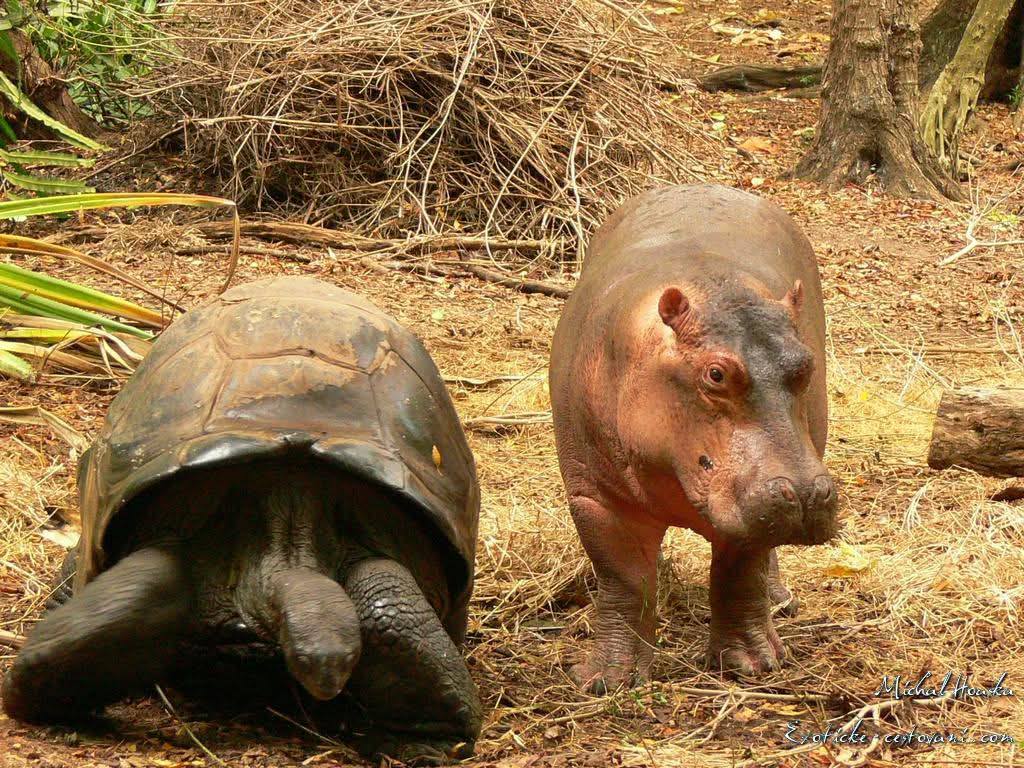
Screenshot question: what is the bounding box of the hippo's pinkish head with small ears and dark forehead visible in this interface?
[658,278,837,547]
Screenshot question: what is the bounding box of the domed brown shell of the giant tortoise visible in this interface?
[76,278,480,599]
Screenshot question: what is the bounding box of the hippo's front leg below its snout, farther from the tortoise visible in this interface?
[708,546,785,675]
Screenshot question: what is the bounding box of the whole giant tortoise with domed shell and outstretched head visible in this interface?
[2,278,480,762]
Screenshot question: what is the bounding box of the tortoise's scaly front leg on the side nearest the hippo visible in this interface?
[345,558,481,764]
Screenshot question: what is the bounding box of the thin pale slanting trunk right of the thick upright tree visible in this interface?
[921,0,1015,173]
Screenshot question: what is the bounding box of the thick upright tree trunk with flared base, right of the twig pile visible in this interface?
[795,0,961,200]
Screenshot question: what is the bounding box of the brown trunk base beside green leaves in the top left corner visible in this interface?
[0,30,100,138]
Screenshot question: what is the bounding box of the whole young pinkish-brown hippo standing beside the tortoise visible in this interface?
[550,185,836,693]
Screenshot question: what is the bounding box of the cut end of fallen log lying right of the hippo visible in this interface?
[928,388,1024,477]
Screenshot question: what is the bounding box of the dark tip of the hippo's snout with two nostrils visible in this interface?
[743,474,837,546]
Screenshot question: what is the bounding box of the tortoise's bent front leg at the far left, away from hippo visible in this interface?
[2,547,194,722]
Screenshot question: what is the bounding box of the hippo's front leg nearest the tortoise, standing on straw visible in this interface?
[569,497,666,695]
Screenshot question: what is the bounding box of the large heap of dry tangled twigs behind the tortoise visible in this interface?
[156,0,707,260]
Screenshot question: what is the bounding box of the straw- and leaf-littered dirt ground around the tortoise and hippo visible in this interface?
[0,0,1024,768]
